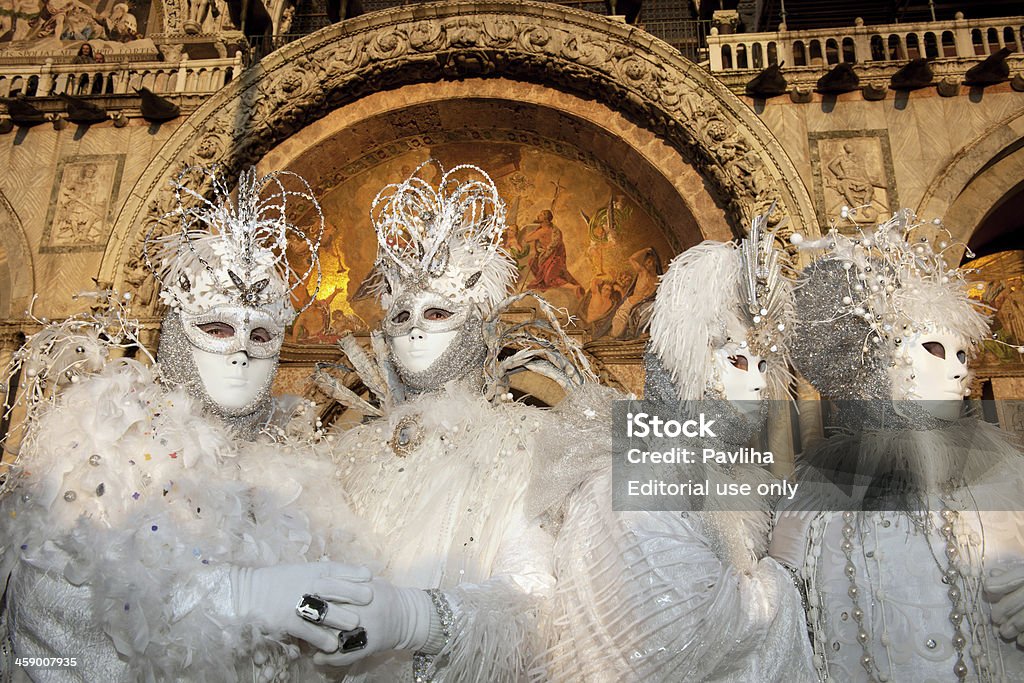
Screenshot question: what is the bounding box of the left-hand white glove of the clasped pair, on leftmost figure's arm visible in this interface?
[231,562,373,650]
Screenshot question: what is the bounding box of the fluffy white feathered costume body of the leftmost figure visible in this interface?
[0,360,370,681]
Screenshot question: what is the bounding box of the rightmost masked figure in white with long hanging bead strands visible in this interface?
[770,211,1024,682]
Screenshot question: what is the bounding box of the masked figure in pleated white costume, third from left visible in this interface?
[538,216,813,682]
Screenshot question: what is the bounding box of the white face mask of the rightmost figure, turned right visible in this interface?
[890,329,970,420]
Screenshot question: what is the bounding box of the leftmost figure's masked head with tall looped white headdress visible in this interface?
[142,167,324,437]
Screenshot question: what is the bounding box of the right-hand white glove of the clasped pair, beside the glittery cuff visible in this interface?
[313,579,444,667]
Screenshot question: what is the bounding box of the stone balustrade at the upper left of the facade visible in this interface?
[0,54,242,97]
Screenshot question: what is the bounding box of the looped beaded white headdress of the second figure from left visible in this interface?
[368,160,516,315]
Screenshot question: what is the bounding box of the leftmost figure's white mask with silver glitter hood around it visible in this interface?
[158,306,284,431]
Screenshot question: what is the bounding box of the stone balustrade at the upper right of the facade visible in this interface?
[708,12,1024,74]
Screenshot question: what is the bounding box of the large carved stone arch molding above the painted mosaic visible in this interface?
[100,1,819,282]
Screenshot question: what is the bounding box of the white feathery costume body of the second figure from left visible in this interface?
[337,383,553,682]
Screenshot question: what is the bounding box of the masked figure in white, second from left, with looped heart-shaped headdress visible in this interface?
[317,166,599,682]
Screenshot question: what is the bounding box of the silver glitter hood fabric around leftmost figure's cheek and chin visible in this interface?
[157,310,279,439]
